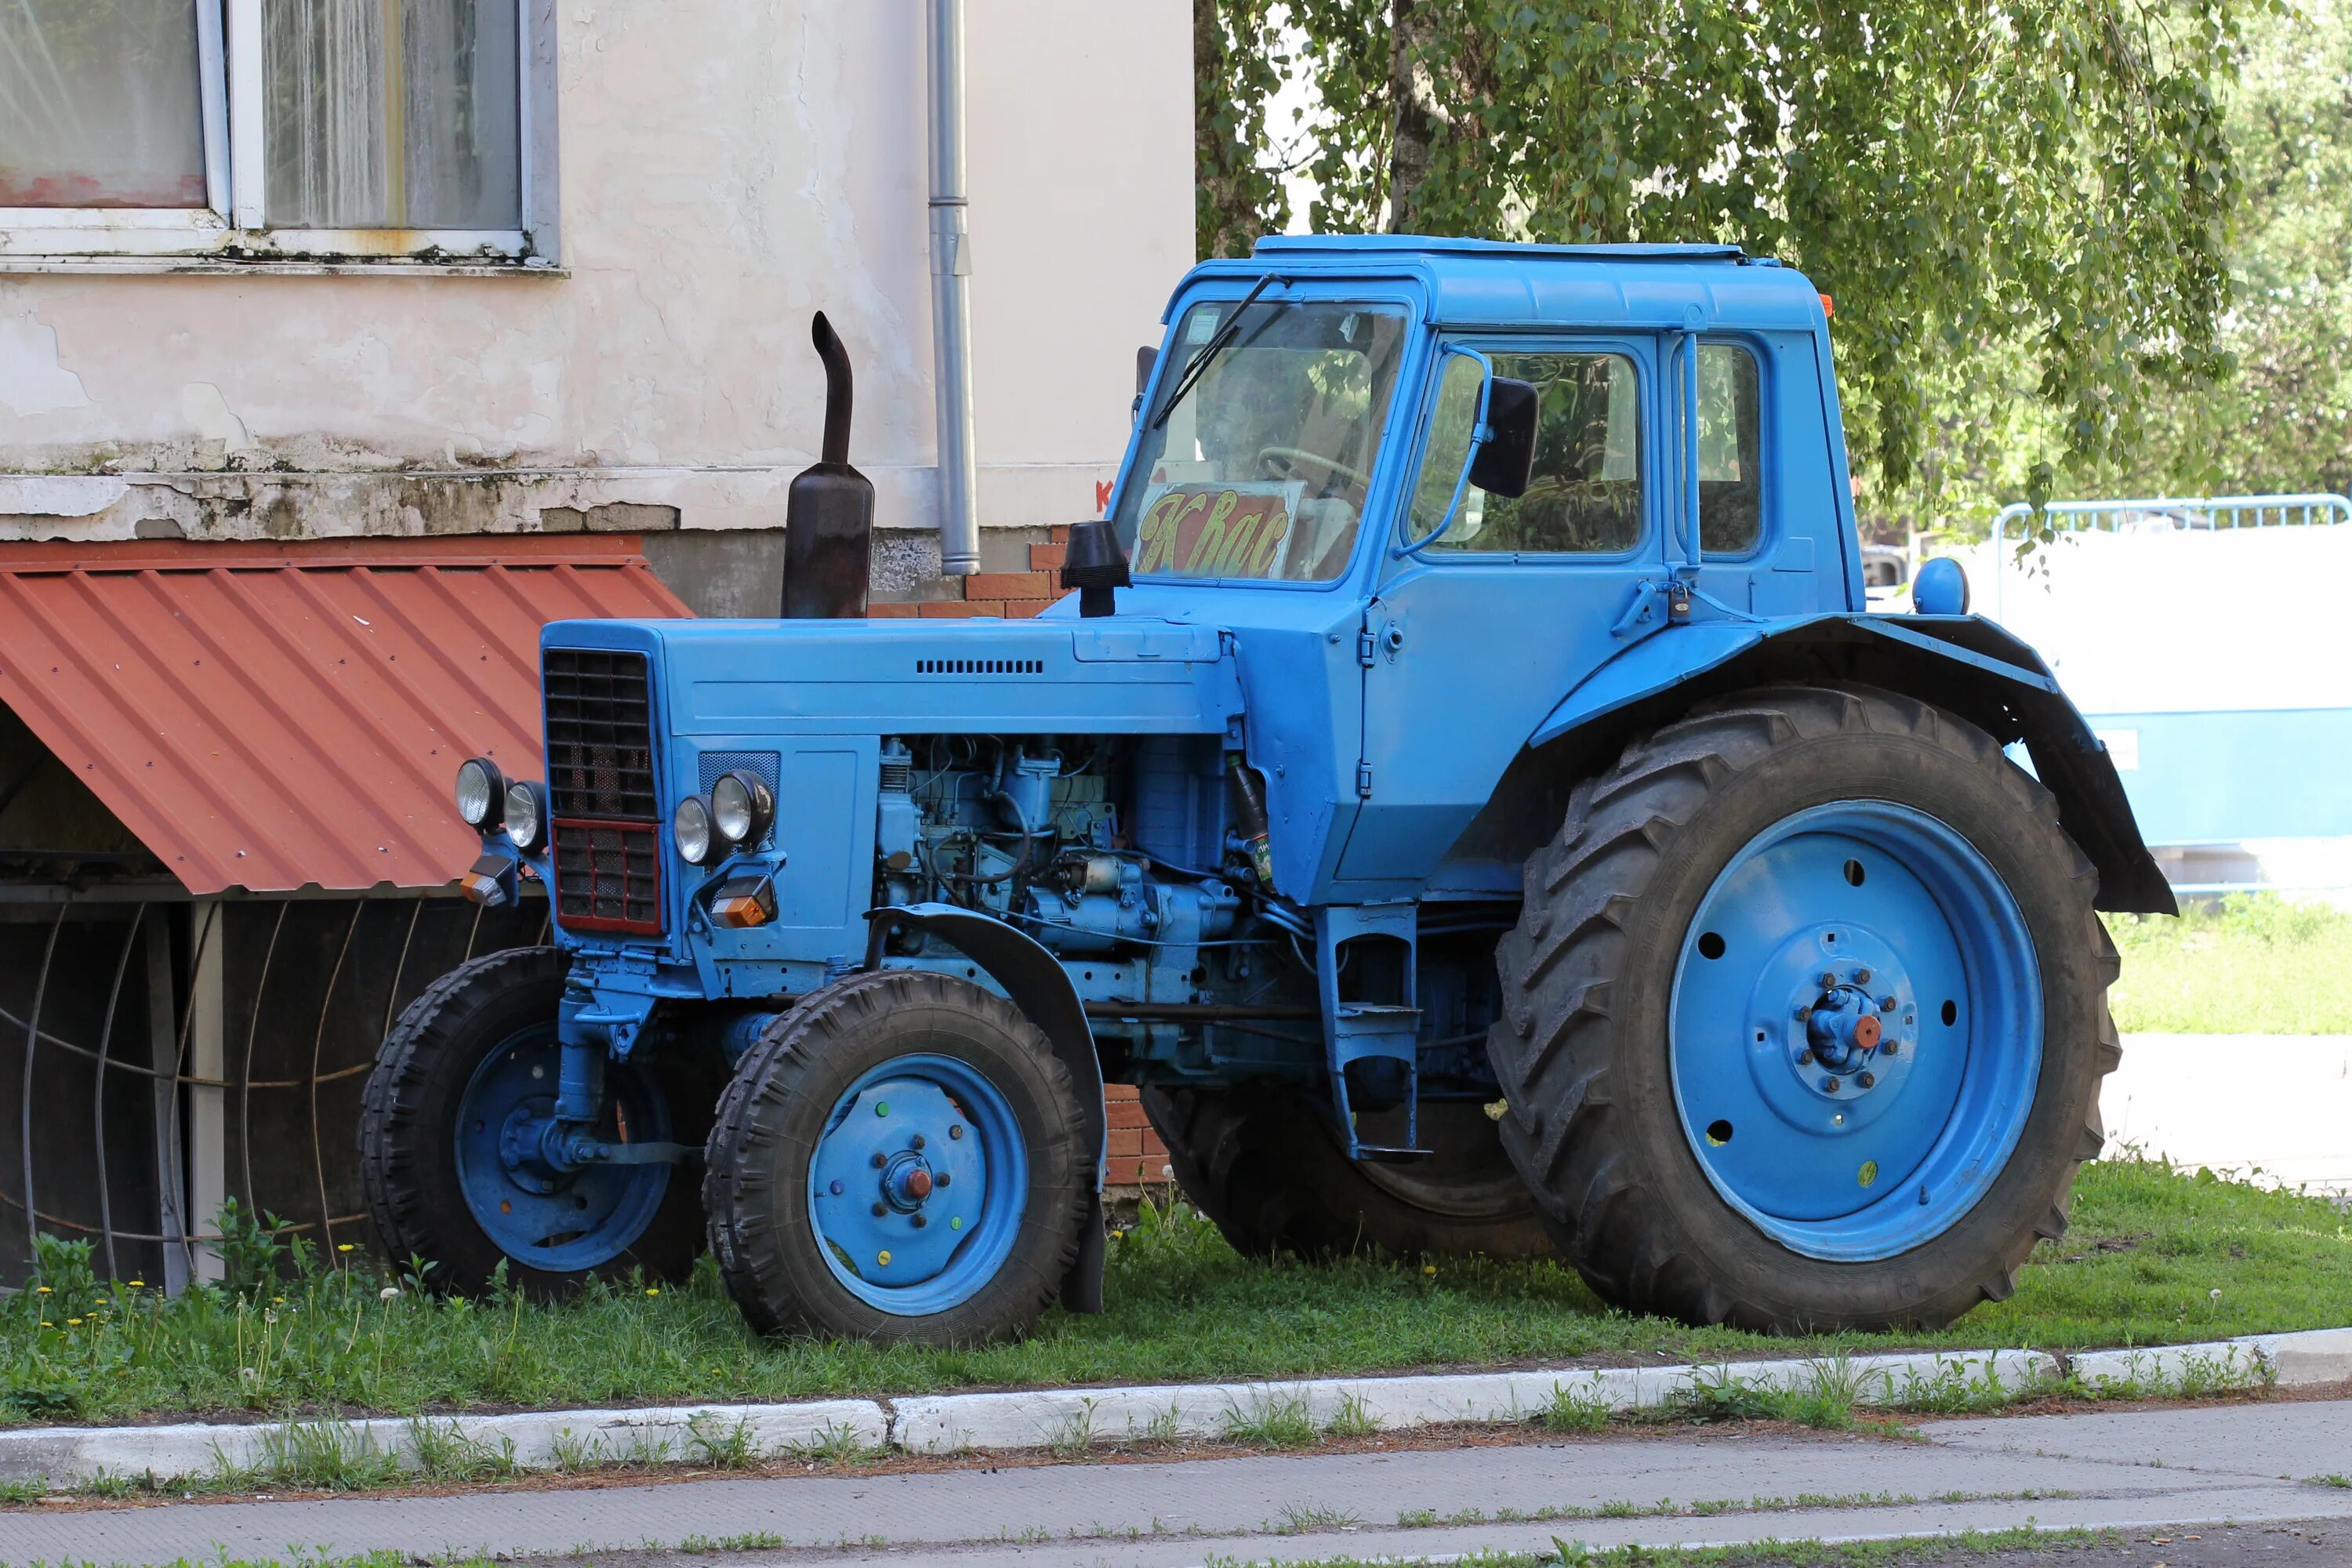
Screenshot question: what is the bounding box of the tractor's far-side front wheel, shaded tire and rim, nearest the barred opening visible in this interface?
[360,947,720,1295]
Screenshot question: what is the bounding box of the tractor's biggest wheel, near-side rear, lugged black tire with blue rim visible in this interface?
[1489,687,2119,1333]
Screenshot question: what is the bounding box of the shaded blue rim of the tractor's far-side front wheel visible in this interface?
[456,1022,670,1274]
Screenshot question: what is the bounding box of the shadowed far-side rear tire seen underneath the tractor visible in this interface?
[1141,1086,1557,1258]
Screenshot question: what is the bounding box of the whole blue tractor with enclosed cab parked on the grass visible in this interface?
[362,238,2173,1342]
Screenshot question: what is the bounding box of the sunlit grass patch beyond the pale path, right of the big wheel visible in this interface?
[2107,893,2352,1034]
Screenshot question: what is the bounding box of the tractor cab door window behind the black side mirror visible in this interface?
[1404,353,1642,555]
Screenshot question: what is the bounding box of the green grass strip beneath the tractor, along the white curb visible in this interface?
[0,1161,2352,1439]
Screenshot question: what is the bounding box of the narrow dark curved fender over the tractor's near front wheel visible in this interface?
[866,902,1110,1312]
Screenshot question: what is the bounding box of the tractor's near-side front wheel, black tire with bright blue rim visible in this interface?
[703,968,1096,1345]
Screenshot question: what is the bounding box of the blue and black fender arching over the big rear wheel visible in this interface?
[1529,614,2178,914]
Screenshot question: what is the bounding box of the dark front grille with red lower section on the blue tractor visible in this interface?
[541,649,661,935]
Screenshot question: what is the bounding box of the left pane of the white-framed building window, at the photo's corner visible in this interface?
[0,0,205,207]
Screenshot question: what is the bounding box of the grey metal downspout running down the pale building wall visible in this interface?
[931,0,981,576]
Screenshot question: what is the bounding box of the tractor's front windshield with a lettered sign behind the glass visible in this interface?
[1115,299,1404,583]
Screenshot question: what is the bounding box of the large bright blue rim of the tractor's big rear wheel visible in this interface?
[1668,799,2042,1262]
